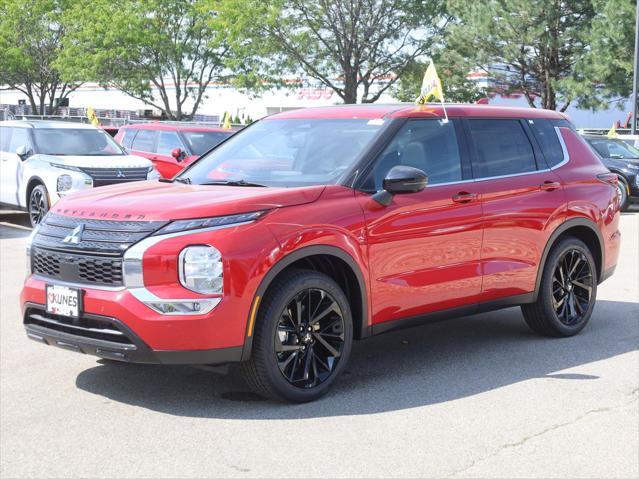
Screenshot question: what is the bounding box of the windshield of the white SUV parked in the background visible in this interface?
[33,128,124,156]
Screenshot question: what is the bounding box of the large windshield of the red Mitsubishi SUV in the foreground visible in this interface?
[179,119,384,187]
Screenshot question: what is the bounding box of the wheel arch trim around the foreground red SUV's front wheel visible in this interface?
[242,245,370,361]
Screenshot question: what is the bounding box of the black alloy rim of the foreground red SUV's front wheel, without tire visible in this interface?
[274,288,344,388]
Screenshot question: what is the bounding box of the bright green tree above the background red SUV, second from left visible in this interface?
[62,0,229,120]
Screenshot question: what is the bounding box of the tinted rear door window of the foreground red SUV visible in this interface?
[468,119,537,178]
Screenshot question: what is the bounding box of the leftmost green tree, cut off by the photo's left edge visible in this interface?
[0,0,81,115]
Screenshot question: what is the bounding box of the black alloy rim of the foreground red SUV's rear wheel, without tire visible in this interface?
[552,249,593,326]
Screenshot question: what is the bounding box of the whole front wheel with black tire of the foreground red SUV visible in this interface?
[241,270,353,403]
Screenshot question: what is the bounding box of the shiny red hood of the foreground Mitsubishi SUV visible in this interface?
[52,180,325,220]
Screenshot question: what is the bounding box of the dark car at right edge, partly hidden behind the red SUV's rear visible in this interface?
[585,135,639,211]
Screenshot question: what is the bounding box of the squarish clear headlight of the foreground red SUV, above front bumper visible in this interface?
[179,246,223,294]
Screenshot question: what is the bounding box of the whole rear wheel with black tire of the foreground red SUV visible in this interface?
[521,236,597,337]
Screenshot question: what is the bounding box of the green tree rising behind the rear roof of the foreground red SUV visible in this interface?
[447,0,600,111]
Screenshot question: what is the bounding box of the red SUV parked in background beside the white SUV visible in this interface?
[115,123,233,178]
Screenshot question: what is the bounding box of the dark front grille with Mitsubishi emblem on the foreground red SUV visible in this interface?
[31,213,167,286]
